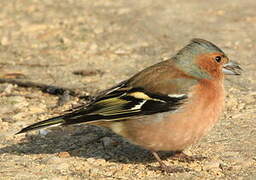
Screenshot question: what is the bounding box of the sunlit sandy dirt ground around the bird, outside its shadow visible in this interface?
[0,0,256,180]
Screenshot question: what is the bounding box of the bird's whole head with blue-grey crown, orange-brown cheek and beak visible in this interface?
[174,39,242,79]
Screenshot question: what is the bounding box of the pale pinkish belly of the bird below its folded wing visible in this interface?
[116,97,222,151]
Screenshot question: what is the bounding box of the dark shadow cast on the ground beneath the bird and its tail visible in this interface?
[0,125,173,164]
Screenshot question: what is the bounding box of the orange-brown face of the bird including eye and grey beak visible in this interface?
[197,52,241,79]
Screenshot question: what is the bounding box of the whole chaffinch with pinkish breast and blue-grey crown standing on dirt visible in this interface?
[17,38,242,172]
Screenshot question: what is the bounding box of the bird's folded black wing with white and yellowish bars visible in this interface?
[60,88,187,124]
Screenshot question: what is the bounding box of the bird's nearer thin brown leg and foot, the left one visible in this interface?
[151,151,189,173]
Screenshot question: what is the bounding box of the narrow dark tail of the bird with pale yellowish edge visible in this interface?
[16,116,66,134]
